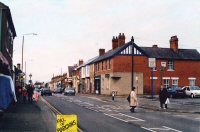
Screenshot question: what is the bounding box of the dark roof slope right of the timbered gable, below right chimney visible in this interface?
[141,47,200,60]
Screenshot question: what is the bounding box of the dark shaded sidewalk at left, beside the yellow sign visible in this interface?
[0,97,56,132]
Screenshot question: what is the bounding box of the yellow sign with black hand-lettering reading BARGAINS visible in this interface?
[56,115,78,132]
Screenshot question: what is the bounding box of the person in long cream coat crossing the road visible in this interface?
[130,87,138,113]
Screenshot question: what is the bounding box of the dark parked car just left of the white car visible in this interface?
[167,86,186,98]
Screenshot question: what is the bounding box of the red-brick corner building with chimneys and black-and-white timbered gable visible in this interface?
[91,34,200,95]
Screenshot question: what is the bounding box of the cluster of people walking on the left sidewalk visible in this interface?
[17,84,34,103]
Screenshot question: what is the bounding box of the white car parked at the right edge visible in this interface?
[182,86,200,98]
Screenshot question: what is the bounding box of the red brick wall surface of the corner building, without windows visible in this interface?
[113,56,200,94]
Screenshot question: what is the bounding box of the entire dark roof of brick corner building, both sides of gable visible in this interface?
[93,41,200,63]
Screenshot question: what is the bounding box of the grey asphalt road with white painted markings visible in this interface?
[44,94,200,132]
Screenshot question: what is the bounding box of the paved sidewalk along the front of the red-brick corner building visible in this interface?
[79,94,200,114]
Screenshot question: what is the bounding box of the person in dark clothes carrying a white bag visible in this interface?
[159,86,169,109]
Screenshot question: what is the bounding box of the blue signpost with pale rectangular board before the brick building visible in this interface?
[149,58,156,99]
